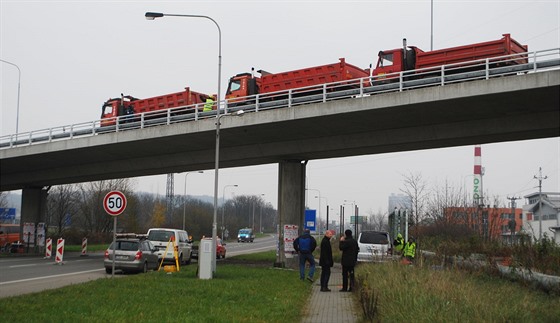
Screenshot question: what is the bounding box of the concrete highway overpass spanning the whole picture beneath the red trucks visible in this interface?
[0,57,560,266]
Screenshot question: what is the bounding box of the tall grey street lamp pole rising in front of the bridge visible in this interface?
[145,12,222,273]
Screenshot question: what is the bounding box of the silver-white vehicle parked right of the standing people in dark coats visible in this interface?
[358,231,392,262]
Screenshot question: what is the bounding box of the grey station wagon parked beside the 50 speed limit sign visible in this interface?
[103,235,159,274]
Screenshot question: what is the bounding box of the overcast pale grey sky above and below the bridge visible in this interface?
[0,0,560,218]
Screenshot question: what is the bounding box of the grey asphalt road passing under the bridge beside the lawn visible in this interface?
[0,235,277,298]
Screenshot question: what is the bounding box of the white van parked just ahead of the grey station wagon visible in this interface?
[148,228,192,265]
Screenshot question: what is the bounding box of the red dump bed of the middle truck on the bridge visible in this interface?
[260,58,369,93]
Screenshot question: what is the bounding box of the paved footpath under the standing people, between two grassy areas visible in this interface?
[302,261,359,323]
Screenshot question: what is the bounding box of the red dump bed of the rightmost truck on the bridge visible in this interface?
[416,34,528,69]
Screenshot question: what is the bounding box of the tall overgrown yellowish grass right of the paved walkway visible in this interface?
[356,263,560,322]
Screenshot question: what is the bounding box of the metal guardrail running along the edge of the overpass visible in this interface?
[0,48,560,149]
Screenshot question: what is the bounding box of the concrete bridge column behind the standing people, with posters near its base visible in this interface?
[274,160,307,269]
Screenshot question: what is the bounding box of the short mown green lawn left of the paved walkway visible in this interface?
[0,253,311,322]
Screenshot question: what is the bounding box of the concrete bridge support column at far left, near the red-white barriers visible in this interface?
[19,187,48,246]
